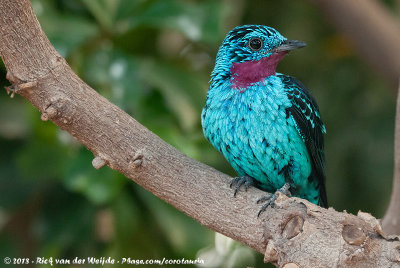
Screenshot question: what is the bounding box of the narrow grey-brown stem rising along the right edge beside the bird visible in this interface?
[382,82,400,234]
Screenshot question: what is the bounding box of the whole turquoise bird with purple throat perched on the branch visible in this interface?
[201,25,328,215]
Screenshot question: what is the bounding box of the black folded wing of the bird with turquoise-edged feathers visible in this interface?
[278,75,328,207]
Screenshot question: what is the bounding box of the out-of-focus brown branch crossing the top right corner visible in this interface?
[312,0,400,88]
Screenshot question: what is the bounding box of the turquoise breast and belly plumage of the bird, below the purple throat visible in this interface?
[202,76,310,189]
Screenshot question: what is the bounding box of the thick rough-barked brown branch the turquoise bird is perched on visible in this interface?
[0,0,400,267]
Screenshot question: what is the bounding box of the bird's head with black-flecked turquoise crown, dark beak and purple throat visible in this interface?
[211,25,306,91]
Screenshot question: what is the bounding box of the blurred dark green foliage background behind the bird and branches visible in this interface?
[0,0,400,267]
